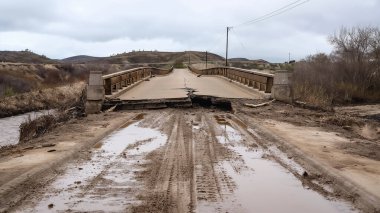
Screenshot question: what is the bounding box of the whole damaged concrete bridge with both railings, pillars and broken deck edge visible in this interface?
[86,66,292,113]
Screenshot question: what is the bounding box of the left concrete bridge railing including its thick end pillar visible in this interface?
[86,67,173,114]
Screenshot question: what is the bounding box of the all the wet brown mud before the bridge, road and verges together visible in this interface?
[0,100,380,212]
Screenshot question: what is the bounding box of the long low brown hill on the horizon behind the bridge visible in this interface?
[61,51,224,64]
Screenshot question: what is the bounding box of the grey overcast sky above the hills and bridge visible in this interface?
[0,0,380,62]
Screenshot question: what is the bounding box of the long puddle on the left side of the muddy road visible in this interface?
[15,122,167,212]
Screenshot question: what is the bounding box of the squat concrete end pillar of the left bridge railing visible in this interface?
[86,71,105,114]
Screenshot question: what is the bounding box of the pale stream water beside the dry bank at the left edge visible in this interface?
[0,110,53,147]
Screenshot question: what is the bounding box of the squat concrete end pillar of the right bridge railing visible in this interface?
[272,70,293,103]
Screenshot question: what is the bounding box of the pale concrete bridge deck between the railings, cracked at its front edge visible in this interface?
[119,69,261,100]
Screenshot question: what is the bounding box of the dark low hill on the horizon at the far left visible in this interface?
[0,50,58,64]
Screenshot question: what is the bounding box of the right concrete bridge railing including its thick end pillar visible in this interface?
[188,66,293,102]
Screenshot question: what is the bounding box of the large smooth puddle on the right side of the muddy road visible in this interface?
[197,122,355,212]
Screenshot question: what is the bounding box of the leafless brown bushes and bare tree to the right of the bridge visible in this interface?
[293,27,380,106]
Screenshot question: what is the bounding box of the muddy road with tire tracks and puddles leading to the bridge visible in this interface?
[8,109,366,212]
